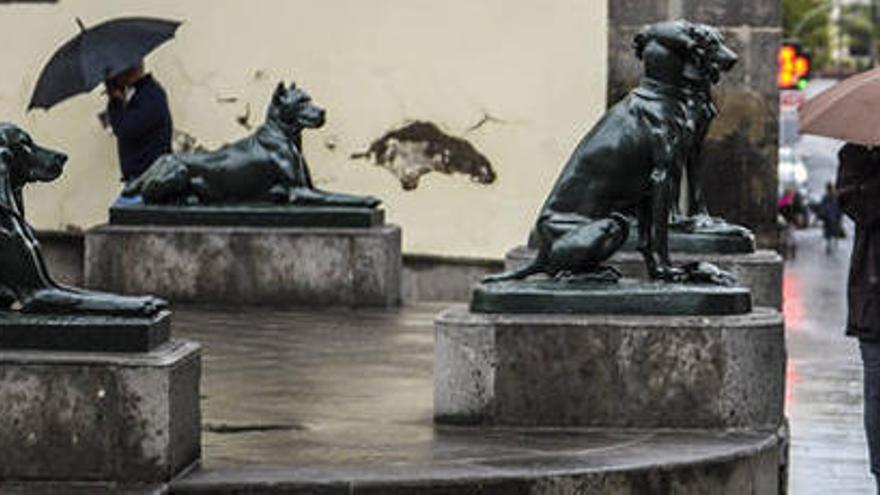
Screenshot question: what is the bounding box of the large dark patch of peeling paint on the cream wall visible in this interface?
[351,121,496,191]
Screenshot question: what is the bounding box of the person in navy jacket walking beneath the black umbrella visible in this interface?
[106,64,173,202]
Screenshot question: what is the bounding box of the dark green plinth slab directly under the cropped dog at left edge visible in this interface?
[0,311,171,352]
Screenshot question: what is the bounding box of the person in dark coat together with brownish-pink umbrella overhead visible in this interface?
[798,69,880,493]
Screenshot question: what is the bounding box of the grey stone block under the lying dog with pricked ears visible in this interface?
[85,225,402,306]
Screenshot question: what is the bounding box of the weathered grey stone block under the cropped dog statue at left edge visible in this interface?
[0,341,201,484]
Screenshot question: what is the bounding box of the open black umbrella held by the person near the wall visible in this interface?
[28,17,180,110]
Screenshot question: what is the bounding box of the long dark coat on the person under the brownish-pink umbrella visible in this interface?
[837,144,880,340]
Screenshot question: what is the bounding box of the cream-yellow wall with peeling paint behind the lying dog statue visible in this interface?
[0,0,607,257]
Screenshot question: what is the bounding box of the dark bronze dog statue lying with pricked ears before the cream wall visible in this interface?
[123,83,380,208]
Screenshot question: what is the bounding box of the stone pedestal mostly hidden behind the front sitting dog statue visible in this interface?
[504,246,783,310]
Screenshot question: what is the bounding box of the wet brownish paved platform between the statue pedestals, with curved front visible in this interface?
[168,304,778,493]
